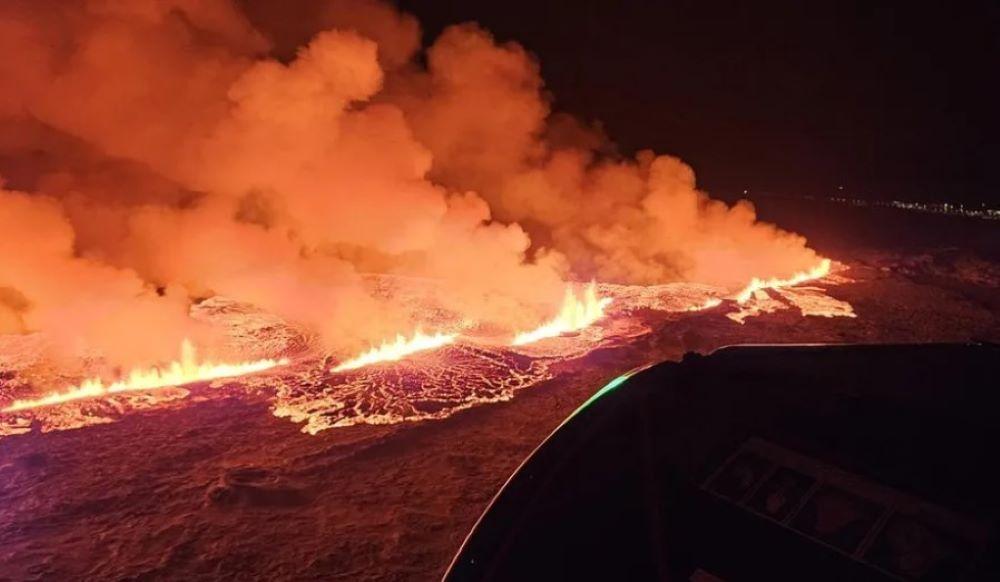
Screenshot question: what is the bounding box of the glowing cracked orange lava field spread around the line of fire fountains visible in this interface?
[0,272,855,437]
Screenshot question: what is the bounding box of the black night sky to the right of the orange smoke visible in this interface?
[399,0,1000,204]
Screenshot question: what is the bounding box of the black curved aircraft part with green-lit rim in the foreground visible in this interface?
[446,345,1000,581]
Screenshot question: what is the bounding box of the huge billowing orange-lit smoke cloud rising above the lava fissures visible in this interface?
[0,0,818,363]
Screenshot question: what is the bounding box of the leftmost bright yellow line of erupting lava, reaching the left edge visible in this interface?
[3,340,289,412]
